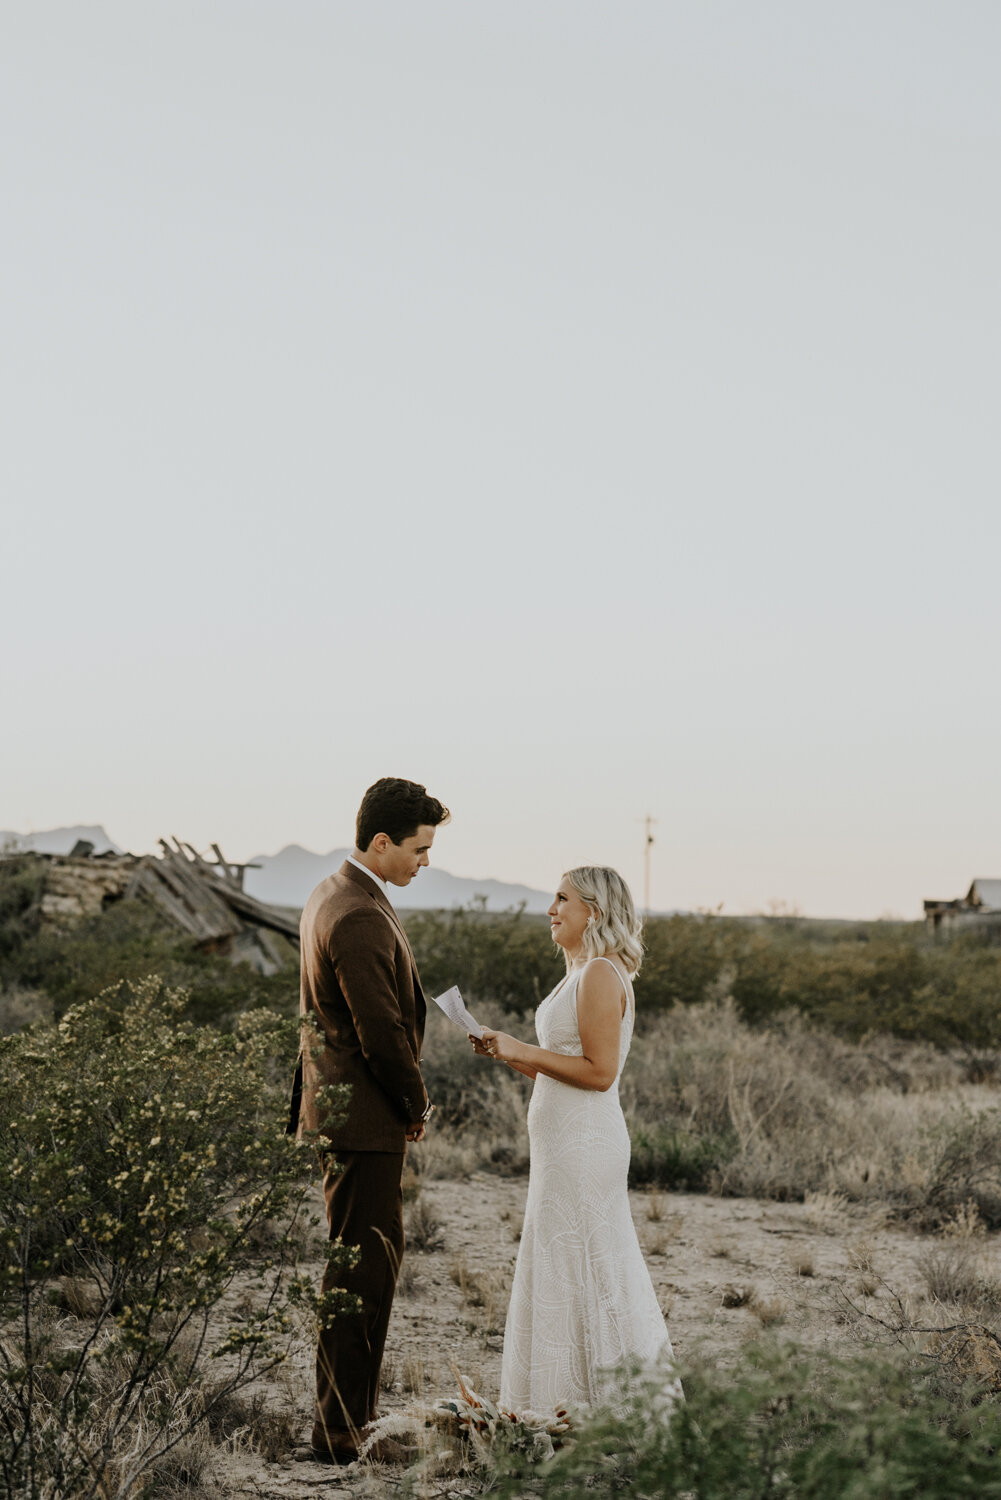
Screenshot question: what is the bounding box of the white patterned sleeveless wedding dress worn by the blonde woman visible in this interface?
[500,959,680,1413]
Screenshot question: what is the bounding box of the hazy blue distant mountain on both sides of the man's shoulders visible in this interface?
[243,845,552,912]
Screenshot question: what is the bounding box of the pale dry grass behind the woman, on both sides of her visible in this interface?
[420,981,1001,1229]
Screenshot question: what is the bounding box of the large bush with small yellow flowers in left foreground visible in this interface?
[0,980,353,1500]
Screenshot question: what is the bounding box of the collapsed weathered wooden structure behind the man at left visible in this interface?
[18,839,299,974]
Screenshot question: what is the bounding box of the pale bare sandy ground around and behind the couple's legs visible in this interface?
[209,1172,978,1500]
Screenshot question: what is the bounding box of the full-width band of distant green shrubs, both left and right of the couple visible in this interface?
[7,855,1001,1056]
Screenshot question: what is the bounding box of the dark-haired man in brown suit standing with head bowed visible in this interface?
[290,776,449,1464]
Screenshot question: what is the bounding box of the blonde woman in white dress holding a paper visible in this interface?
[470,866,672,1412]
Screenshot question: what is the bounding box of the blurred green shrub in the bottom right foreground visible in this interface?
[492,1347,1001,1500]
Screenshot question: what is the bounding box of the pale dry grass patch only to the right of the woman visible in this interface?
[621,1002,1001,1227]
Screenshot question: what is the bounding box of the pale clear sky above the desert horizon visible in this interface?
[0,0,1001,917]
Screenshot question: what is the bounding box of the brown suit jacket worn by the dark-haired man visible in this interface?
[288,860,428,1152]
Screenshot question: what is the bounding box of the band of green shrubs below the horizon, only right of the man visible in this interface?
[407,908,1001,1056]
